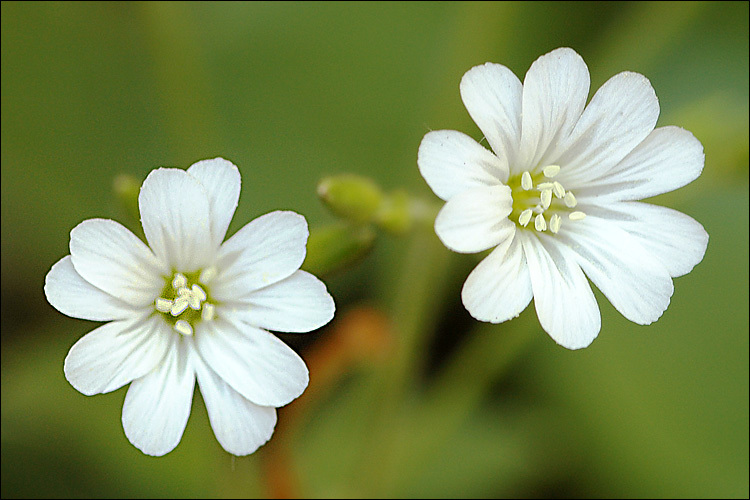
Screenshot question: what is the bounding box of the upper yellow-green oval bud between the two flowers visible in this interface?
[318,174,383,224]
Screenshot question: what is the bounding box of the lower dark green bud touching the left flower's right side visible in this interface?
[302,223,375,276]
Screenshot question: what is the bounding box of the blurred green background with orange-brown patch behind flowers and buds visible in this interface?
[0,2,749,498]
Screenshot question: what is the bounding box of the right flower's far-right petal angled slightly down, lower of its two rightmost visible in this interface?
[586,202,708,278]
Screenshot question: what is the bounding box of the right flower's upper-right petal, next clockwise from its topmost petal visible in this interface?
[553,72,659,186]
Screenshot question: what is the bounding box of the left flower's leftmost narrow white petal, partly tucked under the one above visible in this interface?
[44,255,138,321]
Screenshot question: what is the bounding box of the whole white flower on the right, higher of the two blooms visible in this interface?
[418,48,708,349]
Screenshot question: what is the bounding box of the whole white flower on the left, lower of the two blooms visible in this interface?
[44,158,334,456]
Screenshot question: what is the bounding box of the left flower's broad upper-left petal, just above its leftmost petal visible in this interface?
[70,219,166,307]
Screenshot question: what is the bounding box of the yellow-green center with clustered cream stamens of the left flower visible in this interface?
[154,268,216,335]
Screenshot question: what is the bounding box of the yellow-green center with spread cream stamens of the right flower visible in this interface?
[508,165,586,234]
